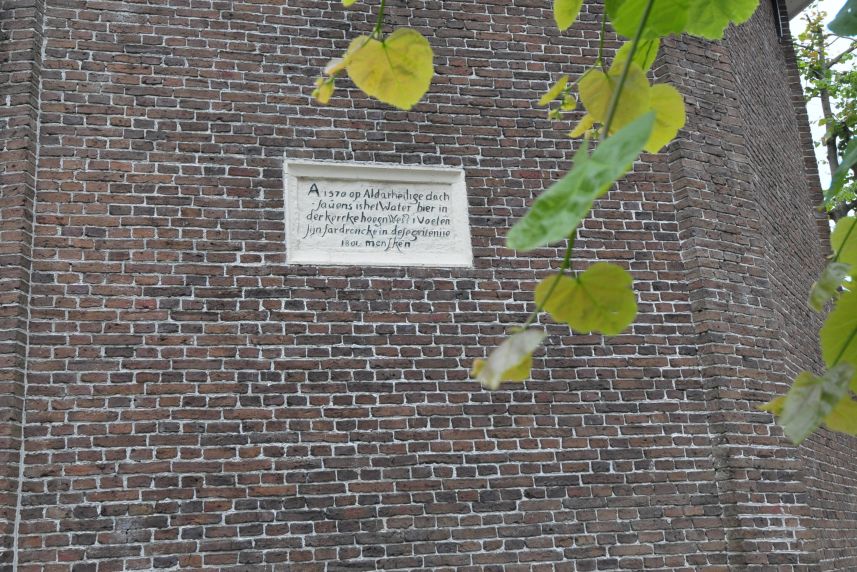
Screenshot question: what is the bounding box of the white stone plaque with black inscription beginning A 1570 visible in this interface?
[283,159,473,266]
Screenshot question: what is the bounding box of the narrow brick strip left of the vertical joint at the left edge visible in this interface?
[0,0,41,568]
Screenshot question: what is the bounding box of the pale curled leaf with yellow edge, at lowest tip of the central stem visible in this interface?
[472,330,546,389]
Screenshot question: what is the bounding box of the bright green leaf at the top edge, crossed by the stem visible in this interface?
[607,0,688,40]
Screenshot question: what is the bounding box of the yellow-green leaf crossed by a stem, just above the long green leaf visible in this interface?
[579,63,651,134]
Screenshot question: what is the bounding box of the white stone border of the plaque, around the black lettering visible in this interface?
[283,157,473,268]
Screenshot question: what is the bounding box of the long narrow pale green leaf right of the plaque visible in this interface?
[506,113,654,250]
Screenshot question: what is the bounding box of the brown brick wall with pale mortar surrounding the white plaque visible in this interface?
[3,0,857,571]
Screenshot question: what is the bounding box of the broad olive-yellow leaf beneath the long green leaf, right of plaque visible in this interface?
[536,262,637,336]
